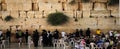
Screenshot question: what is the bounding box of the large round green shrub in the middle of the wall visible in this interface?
[47,12,69,26]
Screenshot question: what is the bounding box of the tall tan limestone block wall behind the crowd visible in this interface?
[0,0,120,33]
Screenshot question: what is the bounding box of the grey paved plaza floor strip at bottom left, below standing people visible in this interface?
[0,43,68,49]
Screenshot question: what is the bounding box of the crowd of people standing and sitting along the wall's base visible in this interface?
[0,28,120,49]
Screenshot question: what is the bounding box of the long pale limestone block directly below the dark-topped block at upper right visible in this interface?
[91,10,110,17]
